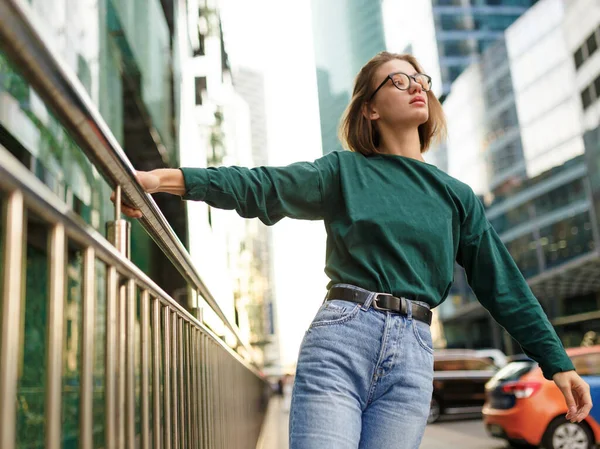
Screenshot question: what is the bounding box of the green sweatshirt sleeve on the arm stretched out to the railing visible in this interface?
[181,156,335,225]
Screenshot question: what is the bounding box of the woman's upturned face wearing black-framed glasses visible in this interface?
[367,59,429,128]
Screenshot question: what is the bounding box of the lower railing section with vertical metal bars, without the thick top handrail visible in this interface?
[0,146,268,449]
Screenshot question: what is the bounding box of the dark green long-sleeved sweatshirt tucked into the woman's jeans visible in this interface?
[181,151,574,379]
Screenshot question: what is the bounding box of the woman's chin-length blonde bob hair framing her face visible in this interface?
[338,51,446,156]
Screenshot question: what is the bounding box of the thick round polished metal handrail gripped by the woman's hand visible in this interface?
[0,0,252,355]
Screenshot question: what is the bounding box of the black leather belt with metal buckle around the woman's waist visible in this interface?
[325,287,432,325]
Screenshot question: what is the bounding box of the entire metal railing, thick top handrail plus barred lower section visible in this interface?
[0,0,269,449]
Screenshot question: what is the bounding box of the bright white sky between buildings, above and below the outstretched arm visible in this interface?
[221,0,327,370]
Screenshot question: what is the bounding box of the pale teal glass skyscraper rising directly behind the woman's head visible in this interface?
[312,0,386,153]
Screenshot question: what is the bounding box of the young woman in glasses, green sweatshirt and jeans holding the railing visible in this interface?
[116,52,592,449]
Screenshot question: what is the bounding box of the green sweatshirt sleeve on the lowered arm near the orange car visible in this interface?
[457,189,575,380]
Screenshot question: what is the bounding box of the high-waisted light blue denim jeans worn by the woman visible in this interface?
[290,284,433,449]
